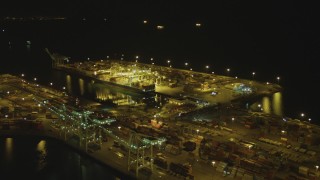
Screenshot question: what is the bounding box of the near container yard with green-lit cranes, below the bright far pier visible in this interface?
[0,72,320,179]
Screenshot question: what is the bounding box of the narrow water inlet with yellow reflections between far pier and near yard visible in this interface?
[53,71,165,107]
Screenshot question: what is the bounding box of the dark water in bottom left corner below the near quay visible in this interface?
[0,136,128,180]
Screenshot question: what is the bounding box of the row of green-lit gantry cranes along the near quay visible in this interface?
[33,98,166,177]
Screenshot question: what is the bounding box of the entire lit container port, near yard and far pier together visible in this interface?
[0,50,320,179]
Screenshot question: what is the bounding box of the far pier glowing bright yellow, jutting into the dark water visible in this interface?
[48,51,281,105]
